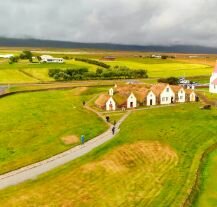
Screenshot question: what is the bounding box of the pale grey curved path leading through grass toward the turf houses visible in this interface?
[0,111,131,189]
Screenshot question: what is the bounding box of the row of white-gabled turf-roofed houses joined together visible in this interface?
[95,83,196,111]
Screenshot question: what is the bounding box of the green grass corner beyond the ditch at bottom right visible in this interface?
[194,150,217,207]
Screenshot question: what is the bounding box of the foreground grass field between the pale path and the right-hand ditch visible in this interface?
[0,104,217,207]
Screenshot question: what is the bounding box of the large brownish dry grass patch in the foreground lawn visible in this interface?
[1,141,178,207]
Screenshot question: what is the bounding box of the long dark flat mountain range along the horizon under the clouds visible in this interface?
[0,38,217,54]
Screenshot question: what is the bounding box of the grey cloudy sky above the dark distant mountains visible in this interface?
[0,0,217,47]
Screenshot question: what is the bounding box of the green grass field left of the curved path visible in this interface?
[0,88,107,174]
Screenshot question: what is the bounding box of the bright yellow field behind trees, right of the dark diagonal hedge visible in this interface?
[105,61,212,78]
